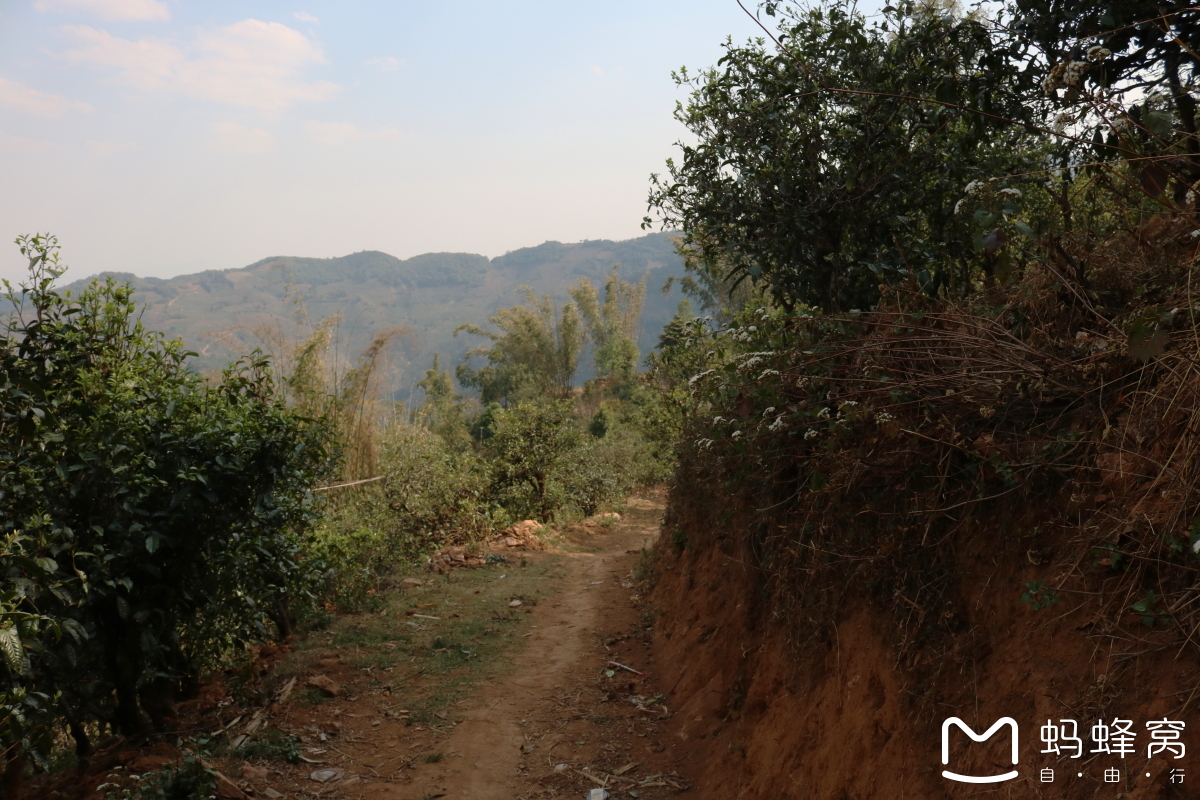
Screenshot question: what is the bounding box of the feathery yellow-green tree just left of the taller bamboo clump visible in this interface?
[455,287,584,405]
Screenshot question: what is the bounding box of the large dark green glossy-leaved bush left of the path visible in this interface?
[0,236,329,753]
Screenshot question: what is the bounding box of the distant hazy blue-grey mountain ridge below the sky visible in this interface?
[67,234,683,401]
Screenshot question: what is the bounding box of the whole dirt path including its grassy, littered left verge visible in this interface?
[25,498,695,800]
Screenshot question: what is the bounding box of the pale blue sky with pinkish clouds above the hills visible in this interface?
[0,0,787,278]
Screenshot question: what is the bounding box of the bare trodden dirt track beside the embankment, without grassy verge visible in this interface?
[374,499,685,800]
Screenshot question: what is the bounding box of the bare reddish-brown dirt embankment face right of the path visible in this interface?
[650,503,1200,800]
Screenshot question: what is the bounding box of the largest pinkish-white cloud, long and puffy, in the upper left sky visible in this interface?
[64,19,341,112]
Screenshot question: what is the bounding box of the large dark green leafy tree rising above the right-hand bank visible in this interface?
[647,0,1037,311]
